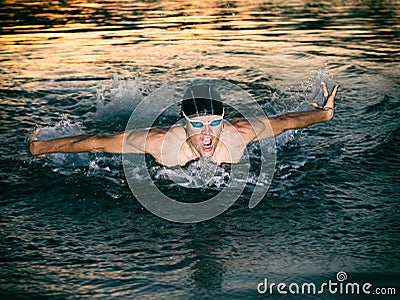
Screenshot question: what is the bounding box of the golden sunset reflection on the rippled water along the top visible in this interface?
[0,0,399,88]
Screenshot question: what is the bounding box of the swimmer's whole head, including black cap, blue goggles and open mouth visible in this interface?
[182,85,224,157]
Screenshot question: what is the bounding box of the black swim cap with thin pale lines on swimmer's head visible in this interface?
[182,84,224,116]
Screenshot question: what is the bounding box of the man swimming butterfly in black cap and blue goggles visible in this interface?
[30,83,339,167]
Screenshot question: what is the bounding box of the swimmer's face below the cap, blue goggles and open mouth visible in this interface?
[186,115,224,156]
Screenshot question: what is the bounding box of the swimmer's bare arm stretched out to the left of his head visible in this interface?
[30,129,165,156]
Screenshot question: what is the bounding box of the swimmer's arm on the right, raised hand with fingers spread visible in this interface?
[250,84,339,141]
